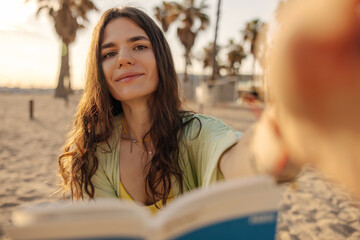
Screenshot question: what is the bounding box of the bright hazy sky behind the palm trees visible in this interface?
[0,0,279,89]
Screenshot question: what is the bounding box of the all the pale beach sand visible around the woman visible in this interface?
[0,93,360,240]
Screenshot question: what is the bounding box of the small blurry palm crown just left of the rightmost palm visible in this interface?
[227,39,246,75]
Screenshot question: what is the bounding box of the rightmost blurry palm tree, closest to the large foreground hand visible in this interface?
[242,19,261,81]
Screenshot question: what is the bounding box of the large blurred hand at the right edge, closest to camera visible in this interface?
[264,0,360,198]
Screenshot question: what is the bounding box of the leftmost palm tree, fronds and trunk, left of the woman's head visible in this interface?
[27,0,98,99]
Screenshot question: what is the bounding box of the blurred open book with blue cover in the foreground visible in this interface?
[5,176,281,240]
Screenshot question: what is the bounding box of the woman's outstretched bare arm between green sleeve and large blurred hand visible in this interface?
[219,109,300,181]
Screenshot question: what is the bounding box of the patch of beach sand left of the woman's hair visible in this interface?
[0,94,77,237]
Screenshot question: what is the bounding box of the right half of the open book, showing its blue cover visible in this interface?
[157,176,281,239]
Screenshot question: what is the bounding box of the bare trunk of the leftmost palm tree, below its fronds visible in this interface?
[55,42,70,99]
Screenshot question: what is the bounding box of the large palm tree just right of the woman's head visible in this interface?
[155,0,209,82]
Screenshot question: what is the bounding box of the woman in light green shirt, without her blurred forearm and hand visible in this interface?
[59,7,290,212]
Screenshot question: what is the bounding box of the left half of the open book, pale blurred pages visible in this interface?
[7,199,150,240]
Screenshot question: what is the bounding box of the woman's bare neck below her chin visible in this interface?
[122,102,152,141]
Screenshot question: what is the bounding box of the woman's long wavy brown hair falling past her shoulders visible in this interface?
[58,7,191,203]
